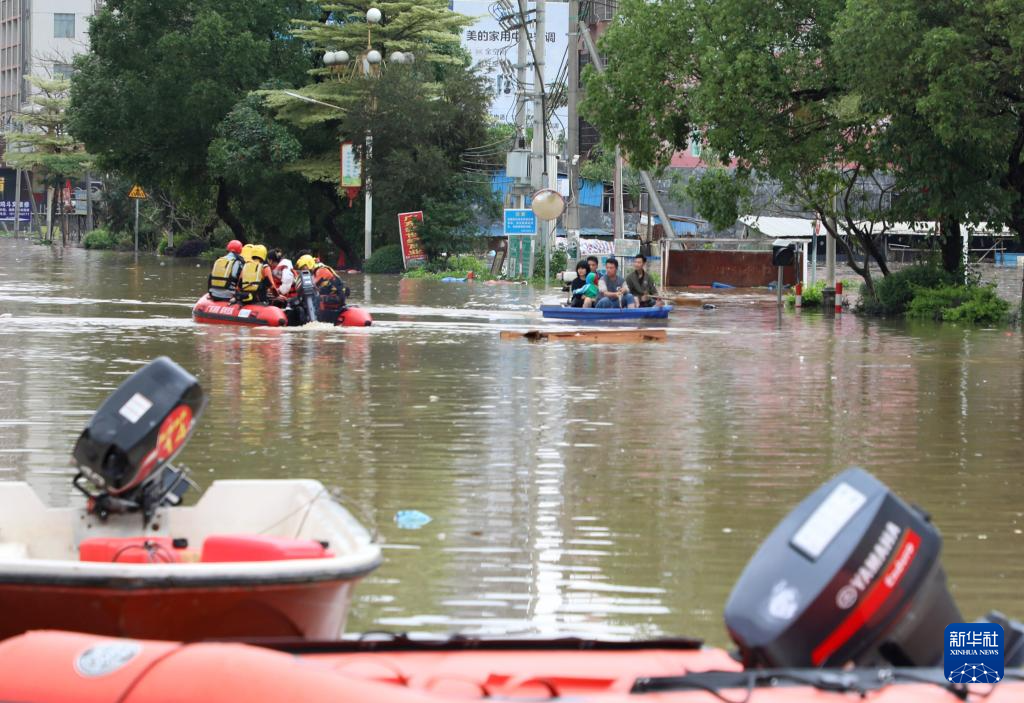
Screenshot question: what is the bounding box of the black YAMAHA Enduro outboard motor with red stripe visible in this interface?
[725,469,964,667]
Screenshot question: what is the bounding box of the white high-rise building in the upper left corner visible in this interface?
[0,0,99,126]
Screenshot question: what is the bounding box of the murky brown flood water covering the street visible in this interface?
[0,239,1024,644]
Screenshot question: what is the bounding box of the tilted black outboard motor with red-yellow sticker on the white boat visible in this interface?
[74,356,206,523]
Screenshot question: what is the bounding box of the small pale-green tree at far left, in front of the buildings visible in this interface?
[4,76,91,241]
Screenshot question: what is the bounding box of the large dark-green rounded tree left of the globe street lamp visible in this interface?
[69,0,310,238]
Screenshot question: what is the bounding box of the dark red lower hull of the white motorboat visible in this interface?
[0,567,354,642]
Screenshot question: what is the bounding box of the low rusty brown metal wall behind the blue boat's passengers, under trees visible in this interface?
[665,250,797,288]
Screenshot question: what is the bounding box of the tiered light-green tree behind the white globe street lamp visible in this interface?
[265,0,494,255]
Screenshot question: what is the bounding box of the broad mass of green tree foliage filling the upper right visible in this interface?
[584,0,1024,293]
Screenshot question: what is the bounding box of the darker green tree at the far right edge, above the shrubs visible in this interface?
[835,0,1024,286]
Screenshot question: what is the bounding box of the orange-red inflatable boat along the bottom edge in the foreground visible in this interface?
[0,631,1024,703]
